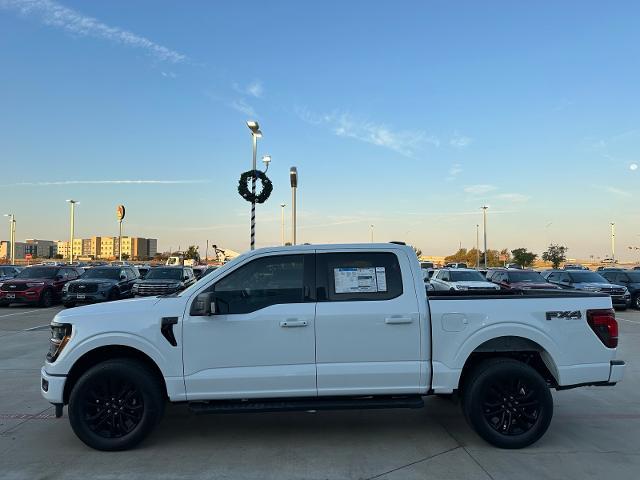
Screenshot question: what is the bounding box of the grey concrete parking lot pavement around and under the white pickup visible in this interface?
[0,307,640,480]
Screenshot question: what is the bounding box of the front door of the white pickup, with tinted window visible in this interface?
[183,254,317,400]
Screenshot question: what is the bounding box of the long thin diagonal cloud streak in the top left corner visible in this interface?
[0,0,187,63]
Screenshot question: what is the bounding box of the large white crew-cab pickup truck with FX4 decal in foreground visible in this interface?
[41,244,625,450]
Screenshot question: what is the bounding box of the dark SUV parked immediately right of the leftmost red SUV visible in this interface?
[62,266,138,307]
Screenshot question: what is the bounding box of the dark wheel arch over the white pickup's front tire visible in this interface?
[63,345,167,404]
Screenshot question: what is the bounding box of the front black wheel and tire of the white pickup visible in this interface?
[68,359,165,451]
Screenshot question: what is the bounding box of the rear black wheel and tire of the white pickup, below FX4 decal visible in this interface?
[462,358,553,448]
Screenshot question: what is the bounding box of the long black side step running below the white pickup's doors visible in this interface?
[189,395,424,414]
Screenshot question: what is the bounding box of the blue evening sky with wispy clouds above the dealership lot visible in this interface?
[0,0,640,260]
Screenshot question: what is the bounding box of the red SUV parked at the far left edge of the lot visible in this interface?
[0,265,83,307]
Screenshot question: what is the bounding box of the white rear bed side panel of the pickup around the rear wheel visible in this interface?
[428,296,616,393]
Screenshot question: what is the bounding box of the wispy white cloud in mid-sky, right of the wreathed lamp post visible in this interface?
[296,108,440,157]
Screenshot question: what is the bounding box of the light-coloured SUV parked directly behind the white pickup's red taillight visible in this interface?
[542,270,631,309]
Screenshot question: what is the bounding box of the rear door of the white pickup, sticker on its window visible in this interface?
[316,250,426,395]
